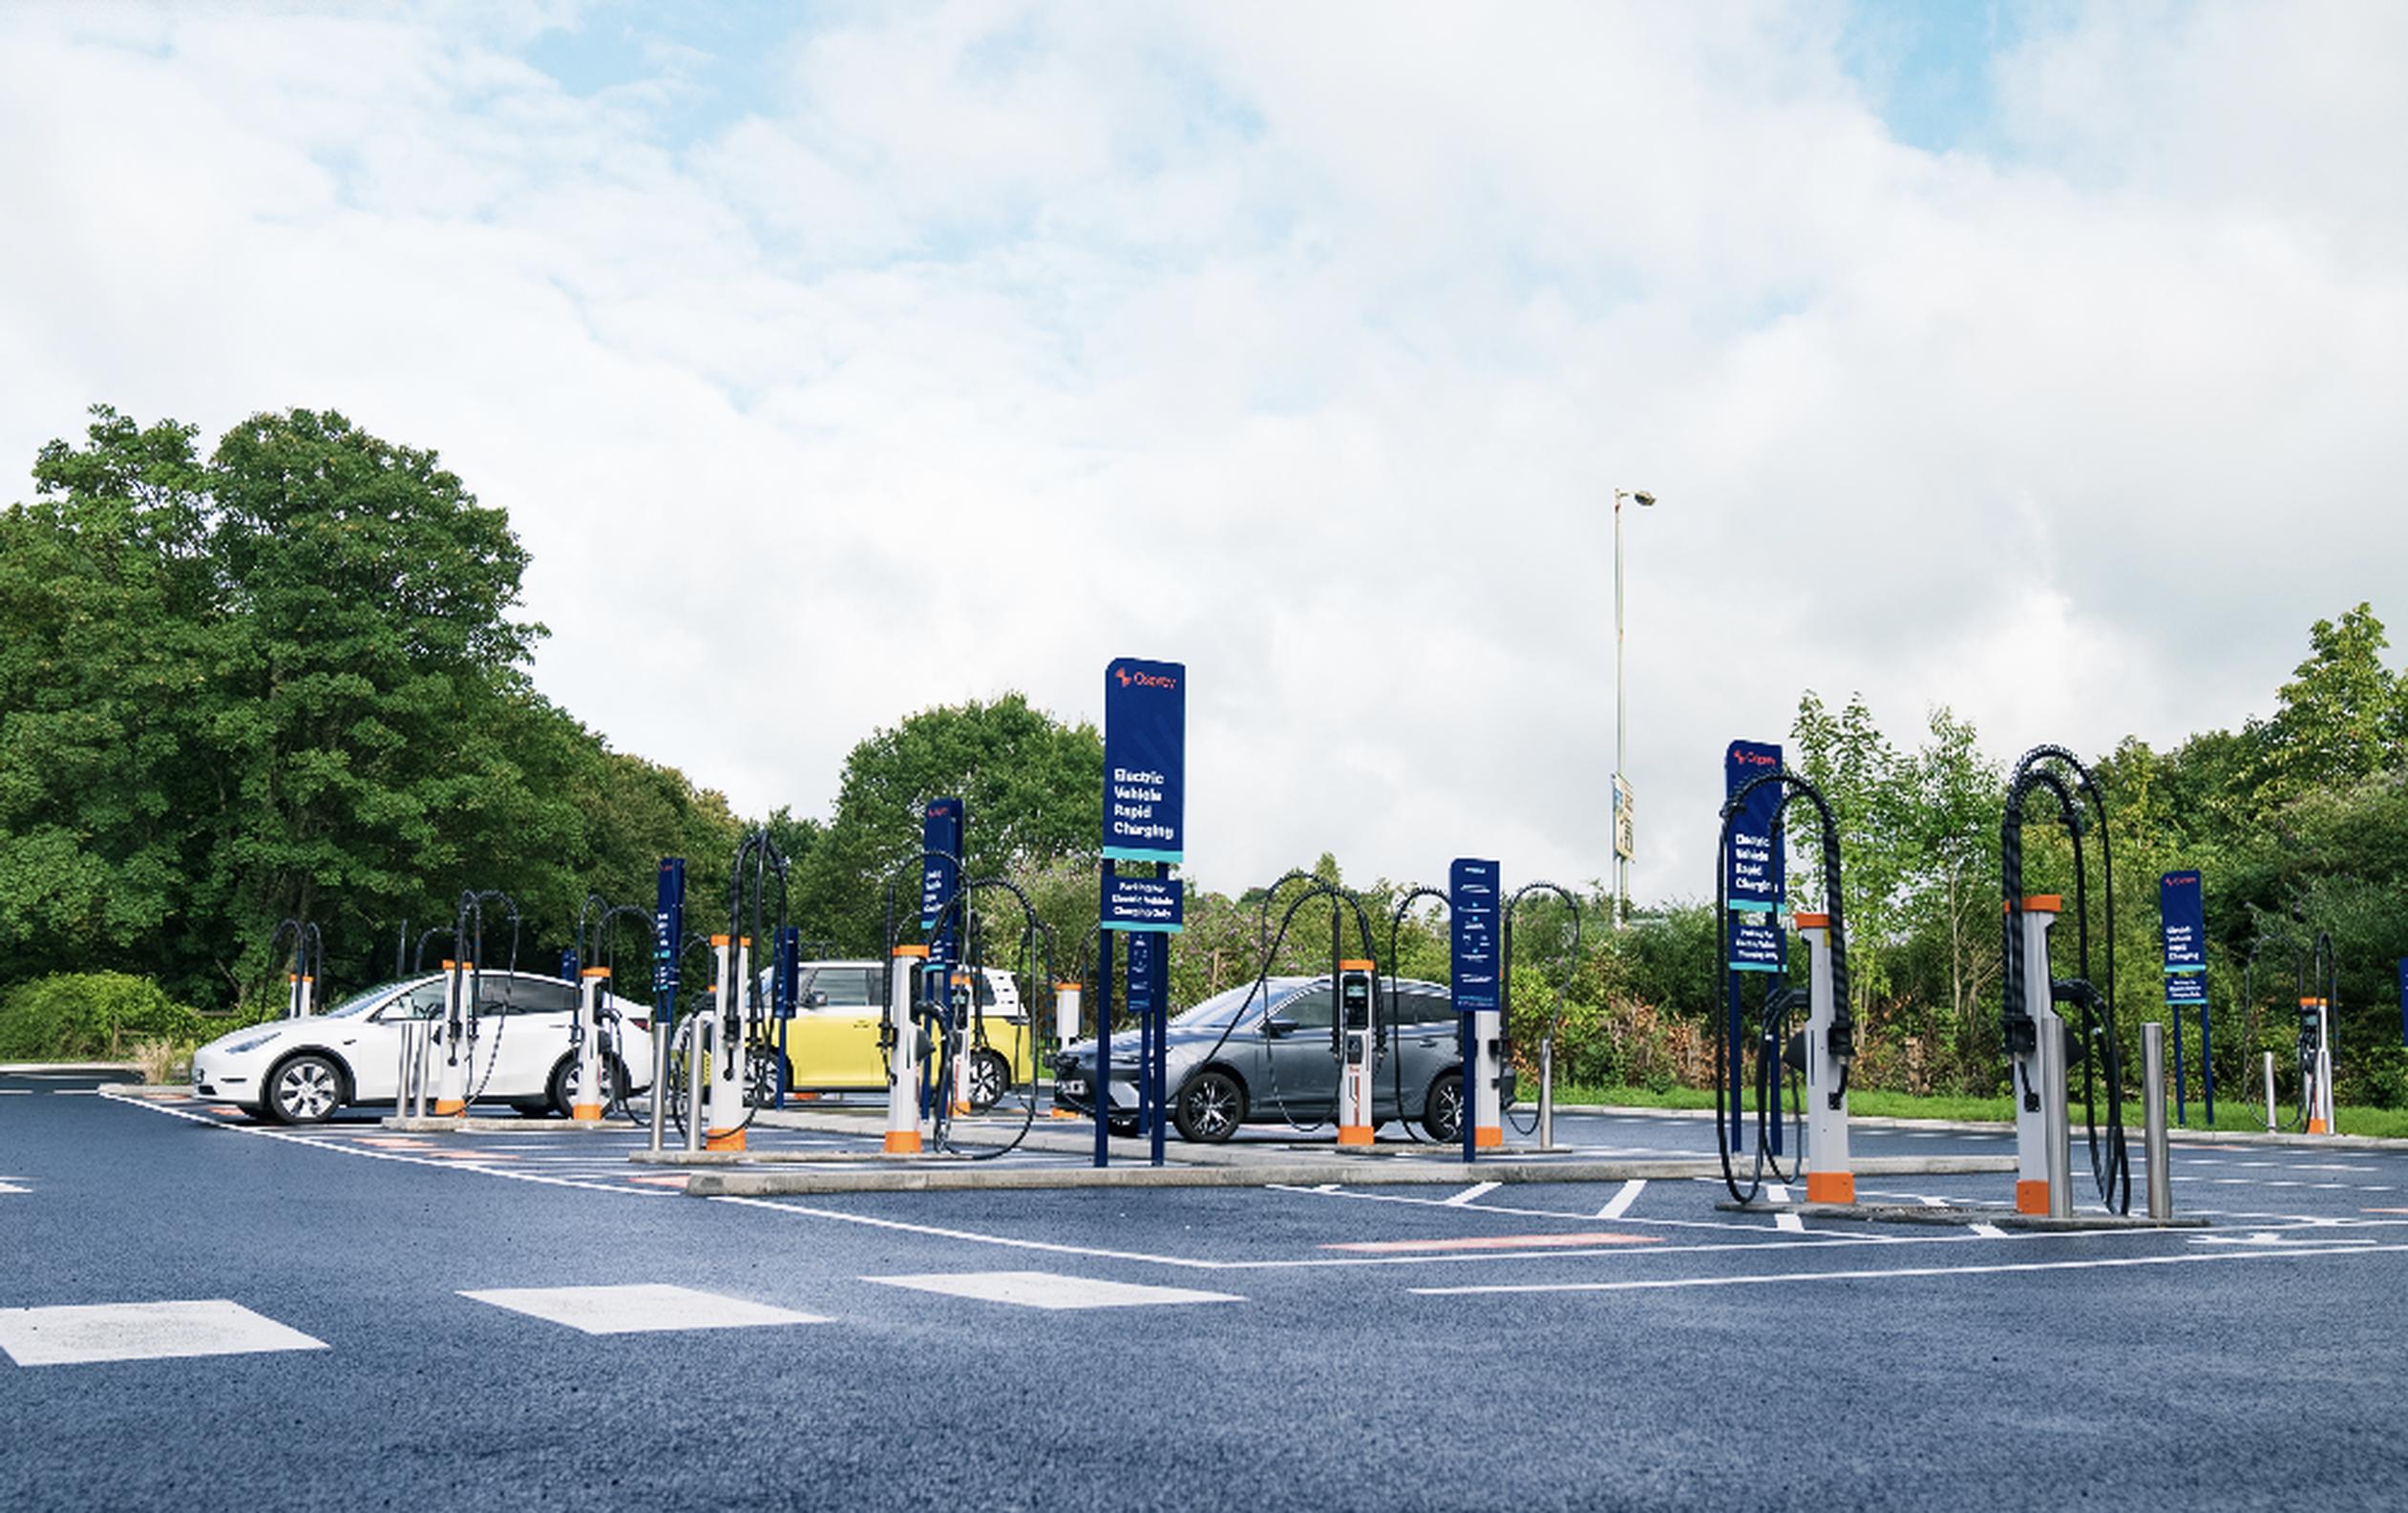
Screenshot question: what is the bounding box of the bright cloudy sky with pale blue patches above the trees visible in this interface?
[0,0,2408,898]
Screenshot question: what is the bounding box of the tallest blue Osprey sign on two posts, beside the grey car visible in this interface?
[1093,658,1187,1166]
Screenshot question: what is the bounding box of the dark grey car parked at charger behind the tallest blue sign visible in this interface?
[1055,976,1464,1142]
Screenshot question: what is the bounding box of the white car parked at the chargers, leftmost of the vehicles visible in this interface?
[193,971,650,1125]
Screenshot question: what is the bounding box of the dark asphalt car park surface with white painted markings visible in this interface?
[0,1077,2408,1510]
